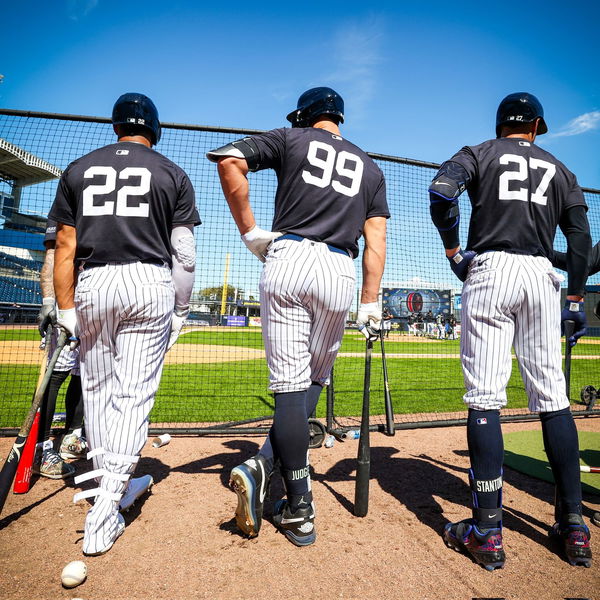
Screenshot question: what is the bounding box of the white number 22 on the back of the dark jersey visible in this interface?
[82,167,152,217]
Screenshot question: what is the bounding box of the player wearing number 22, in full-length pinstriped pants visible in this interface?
[50,93,200,555]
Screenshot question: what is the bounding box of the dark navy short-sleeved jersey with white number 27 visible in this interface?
[450,138,587,257]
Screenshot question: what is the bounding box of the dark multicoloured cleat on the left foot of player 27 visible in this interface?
[443,519,506,571]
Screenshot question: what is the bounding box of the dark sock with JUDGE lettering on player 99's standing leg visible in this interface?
[270,390,309,496]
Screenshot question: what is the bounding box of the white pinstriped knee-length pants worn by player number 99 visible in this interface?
[260,239,356,393]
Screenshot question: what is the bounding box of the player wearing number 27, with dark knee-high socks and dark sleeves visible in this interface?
[429,92,592,570]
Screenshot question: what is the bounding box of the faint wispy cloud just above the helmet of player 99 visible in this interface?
[323,18,383,122]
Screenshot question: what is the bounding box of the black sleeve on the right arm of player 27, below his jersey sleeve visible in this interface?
[559,205,592,296]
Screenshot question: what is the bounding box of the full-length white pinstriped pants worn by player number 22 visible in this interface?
[75,262,175,552]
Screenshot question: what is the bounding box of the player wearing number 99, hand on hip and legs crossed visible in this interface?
[207,87,389,546]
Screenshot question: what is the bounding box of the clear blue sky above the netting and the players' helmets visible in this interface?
[0,0,600,188]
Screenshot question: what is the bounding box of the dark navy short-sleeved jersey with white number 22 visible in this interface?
[49,142,200,265]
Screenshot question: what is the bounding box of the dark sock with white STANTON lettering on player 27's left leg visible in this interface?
[467,409,504,529]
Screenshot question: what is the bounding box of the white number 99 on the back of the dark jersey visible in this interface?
[302,140,364,198]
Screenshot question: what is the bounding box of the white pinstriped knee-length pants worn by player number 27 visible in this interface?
[460,252,569,412]
